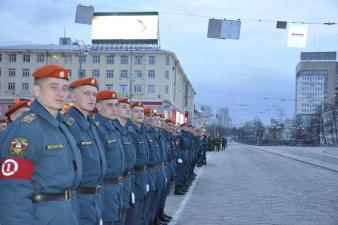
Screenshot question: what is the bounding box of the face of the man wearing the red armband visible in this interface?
[34,77,69,111]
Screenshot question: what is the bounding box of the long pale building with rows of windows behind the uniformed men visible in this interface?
[0,39,196,123]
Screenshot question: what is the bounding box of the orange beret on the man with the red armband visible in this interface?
[33,64,69,80]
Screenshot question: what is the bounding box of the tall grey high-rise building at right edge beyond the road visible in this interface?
[296,52,338,129]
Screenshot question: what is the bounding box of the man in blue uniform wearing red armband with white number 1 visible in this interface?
[0,65,82,225]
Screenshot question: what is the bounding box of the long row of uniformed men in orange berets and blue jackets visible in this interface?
[0,65,207,225]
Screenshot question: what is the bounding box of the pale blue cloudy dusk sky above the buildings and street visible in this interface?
[0,0,338,124]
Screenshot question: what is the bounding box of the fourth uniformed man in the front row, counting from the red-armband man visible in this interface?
[113,98,136,225]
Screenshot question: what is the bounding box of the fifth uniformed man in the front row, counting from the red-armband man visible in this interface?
[127,102,150,225]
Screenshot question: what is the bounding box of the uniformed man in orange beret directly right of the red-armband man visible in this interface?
[64,78,107,225]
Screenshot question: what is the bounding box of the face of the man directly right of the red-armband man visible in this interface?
[72,85,97,112]
